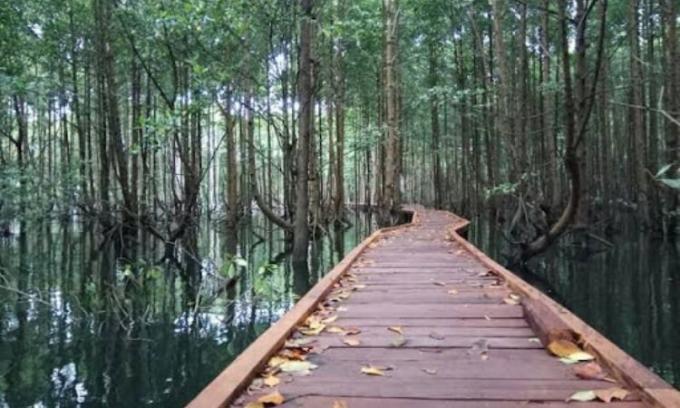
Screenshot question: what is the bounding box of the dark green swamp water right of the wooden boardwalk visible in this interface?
[469,215,680,387]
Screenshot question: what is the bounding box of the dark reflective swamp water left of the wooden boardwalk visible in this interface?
[0,214,374,407]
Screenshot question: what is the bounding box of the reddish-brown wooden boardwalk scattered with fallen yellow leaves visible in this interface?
[190,209,680,408]
